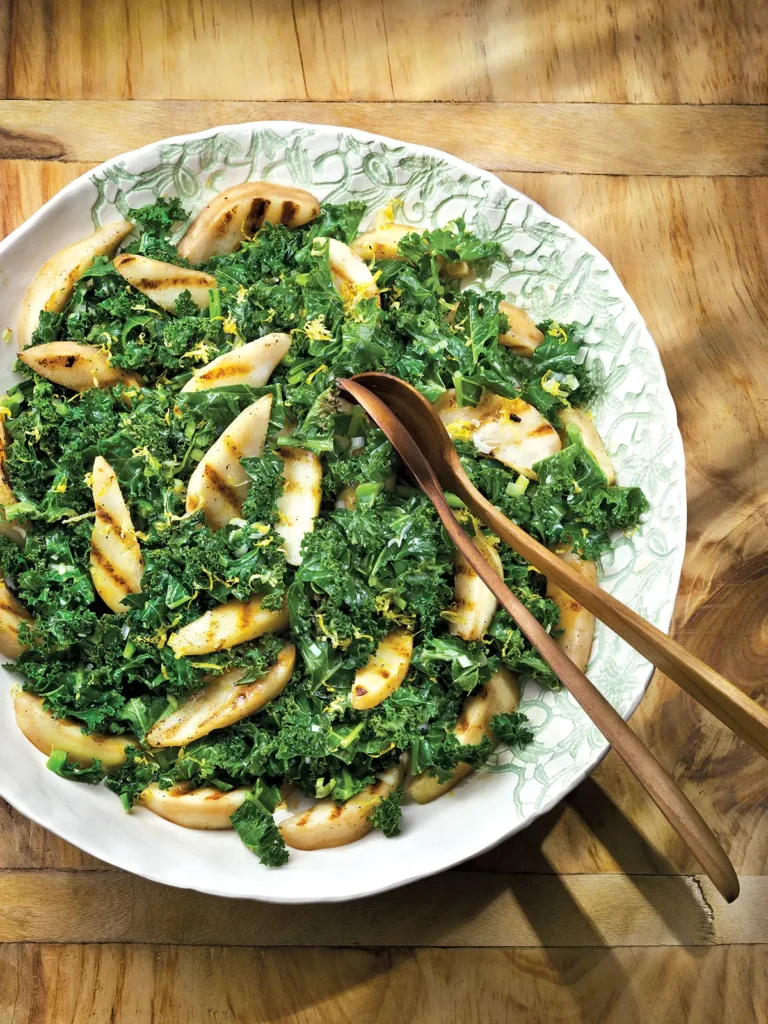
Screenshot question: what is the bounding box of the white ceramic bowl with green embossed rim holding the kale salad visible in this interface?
[0,122,685,903]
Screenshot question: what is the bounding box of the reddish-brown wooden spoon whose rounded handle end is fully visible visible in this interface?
[338,374,739,903]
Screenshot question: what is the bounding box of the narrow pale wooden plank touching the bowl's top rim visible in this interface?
[0,100,768,175]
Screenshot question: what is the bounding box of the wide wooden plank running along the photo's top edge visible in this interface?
[4,0,768,102]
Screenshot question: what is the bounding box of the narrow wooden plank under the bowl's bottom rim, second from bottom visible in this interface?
[0,869,768,947]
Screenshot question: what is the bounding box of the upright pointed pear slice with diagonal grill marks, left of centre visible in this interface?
[90,455,144,612]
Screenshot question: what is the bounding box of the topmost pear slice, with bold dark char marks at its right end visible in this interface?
[177,181,319,263]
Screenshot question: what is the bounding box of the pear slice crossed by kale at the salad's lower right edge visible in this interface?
[408,669,520,804]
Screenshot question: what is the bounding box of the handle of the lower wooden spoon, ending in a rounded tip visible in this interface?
[434,487,739,903]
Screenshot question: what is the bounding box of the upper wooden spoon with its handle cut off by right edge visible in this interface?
[344,373,768,758]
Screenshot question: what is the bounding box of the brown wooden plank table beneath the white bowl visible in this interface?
[0,0,768,1024]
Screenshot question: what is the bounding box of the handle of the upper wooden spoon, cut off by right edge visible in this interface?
[456,473,768,758]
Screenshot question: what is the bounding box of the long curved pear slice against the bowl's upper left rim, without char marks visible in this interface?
[16,220,133,349]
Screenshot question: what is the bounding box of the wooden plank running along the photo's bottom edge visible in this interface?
[0,945,768,1024]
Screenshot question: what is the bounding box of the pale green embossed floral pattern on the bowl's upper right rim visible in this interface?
[92,124,685,806]
